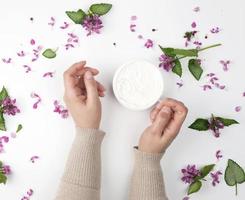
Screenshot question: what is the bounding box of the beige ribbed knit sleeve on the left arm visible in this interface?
[55,128,105,200]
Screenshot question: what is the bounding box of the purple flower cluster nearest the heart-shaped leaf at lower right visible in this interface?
[181,165,200,184]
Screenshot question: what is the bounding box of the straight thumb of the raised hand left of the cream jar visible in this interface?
[84,71,99,102]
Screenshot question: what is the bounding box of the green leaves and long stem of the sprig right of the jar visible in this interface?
[159,44,221,80]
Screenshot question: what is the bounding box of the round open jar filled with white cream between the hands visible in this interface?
[113,60,164,110]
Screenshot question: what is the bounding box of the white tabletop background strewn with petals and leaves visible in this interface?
[0,0,245,200]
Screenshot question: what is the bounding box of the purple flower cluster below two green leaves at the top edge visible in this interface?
[82,15,103,36]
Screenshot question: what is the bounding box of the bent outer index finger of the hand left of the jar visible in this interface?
[64,61,86,90]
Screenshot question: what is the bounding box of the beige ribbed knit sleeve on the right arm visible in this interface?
[129,149,167,200]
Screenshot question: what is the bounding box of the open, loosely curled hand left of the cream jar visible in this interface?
[64,61,105,129]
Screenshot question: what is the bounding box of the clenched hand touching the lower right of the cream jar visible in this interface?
[138,99,188,153]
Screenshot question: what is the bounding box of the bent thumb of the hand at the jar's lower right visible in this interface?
[152,106,172,136]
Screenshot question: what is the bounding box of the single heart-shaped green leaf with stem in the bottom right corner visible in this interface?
[225,159,245,195]
